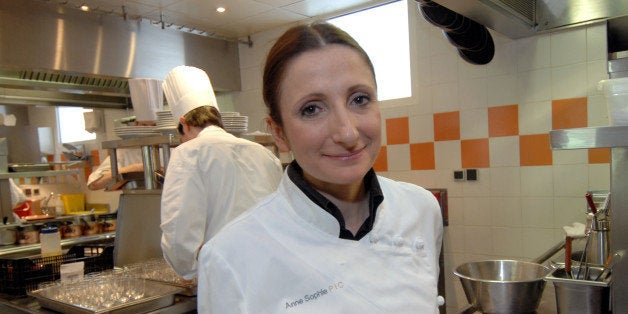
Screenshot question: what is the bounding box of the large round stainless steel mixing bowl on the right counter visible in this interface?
[454,260,550,313]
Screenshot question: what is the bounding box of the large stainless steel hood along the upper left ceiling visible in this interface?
[0,0,240,108]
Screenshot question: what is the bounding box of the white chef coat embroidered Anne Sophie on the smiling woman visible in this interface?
[198,168,443,314]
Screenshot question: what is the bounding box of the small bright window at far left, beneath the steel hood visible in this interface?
[57,107,96,143]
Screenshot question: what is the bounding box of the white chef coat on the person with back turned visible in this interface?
[161,126,282,279]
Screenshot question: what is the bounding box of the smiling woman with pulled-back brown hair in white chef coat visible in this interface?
[198,23,442,314]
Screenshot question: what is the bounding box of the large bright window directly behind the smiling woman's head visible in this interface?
[329,0,412,100]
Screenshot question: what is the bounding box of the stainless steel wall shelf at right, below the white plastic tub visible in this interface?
[550,125,628,149]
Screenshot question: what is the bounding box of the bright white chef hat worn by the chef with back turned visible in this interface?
[163,65,220,121]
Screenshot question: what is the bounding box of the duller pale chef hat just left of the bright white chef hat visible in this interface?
[129,78,164,121]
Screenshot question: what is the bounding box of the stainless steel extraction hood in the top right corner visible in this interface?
[434,0,628,39]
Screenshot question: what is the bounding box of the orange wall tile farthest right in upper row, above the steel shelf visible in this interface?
[552,98,587,130]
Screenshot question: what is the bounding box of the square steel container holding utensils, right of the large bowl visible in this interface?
[545,266,611,314]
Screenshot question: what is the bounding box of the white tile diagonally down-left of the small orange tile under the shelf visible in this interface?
[553,165,589,197]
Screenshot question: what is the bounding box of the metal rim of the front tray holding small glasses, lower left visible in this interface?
[29,279,182,314]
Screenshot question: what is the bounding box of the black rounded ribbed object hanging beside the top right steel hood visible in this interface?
[415,0,495,64]
